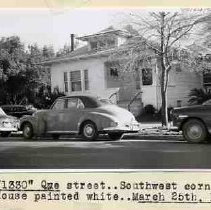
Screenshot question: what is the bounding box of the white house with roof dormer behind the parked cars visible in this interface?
[43,27,203,114]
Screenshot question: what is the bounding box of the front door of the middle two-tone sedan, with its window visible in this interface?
[46,98,66,133]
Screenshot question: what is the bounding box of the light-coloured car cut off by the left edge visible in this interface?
[0,108,19,137]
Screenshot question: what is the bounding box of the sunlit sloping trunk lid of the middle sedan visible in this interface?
[95,105,135,121]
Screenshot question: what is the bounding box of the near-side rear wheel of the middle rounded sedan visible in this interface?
[81,121,98,141]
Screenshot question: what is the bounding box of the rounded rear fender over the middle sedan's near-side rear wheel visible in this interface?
[78,112,115,132]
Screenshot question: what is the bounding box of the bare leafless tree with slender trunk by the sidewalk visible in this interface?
[113,10,209,125]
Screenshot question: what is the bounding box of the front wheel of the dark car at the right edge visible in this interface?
[182,119,208,143]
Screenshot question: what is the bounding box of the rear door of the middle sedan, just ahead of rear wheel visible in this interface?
[64,97,84,133]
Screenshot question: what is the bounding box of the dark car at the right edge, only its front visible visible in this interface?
[171,100,211,143]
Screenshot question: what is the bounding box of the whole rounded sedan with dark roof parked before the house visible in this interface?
[21,96,139,140]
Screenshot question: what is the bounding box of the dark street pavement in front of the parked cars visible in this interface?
[0,136,211,169]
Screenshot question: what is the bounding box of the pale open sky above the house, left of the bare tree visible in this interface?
[0,9,129,49]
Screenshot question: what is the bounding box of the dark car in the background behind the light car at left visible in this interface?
[1,105,36,118]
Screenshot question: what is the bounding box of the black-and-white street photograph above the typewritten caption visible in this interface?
[0,8,211,169]
